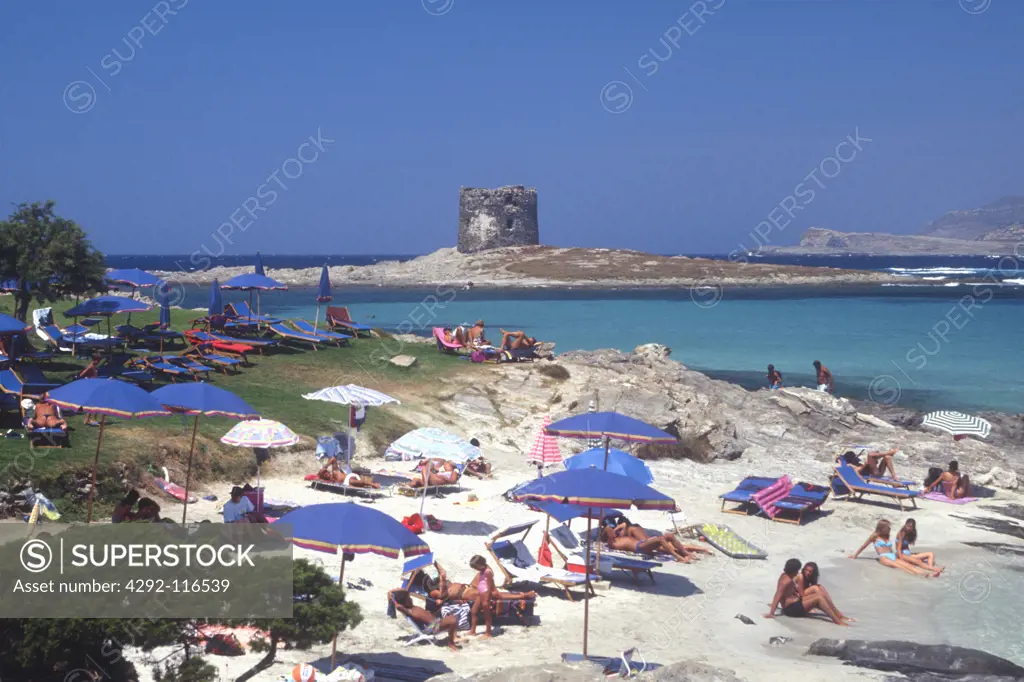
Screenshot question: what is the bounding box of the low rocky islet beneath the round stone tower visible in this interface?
[149,246,907,286]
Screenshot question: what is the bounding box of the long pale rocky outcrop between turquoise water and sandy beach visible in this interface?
[409,344,1024,489]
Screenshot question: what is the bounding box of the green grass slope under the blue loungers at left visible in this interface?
[0,296,466,506]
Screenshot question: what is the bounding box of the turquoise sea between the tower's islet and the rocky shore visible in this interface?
[186,278,1024,413]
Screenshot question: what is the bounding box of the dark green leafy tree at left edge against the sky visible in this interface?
[0,201,105,321]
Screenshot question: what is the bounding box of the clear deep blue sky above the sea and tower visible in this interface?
[0,0,1024,254]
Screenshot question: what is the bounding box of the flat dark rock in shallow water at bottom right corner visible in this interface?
[807,639,1024,679]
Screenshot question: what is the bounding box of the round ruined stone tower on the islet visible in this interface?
[459,184,541,253]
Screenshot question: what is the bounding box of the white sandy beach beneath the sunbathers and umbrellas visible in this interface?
[130,434,1024,681]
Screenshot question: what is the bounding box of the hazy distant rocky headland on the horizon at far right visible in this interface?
[761,197,1024,256]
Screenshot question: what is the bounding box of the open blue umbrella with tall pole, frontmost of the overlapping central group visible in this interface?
[512,468,676,658]
